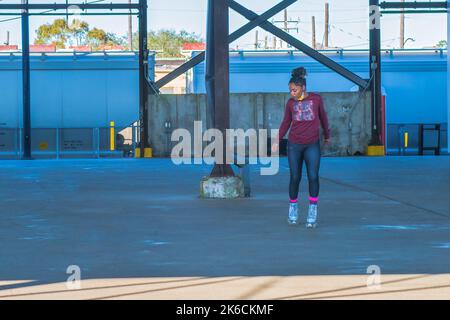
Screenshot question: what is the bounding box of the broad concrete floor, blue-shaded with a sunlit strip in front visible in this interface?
[0,156,450,299]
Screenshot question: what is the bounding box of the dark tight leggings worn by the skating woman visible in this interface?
[287,140,320,200]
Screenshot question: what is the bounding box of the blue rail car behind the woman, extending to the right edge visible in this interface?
[192,50,447,124]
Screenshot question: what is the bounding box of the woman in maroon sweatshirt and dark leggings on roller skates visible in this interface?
[272,67,330,228]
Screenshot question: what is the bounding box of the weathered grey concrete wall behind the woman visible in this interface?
[148,92,371,157]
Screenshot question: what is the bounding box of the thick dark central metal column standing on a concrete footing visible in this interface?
[205,0,234,177]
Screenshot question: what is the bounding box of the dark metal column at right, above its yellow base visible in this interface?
[369,0,381,146]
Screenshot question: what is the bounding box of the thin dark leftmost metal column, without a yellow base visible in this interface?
[22,0,31,160]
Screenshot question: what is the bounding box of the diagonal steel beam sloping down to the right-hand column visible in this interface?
[230,0,368,88]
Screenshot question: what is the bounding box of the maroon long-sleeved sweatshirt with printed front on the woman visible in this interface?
[279,93,330,144]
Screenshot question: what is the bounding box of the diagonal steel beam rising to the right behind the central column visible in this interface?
[156,0,297,89]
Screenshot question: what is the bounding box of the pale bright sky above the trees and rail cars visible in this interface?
[0,0,447,49]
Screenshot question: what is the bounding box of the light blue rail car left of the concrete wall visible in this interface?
[0,53,154,128]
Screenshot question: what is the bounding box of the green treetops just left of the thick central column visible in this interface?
[133,29,203,57]
